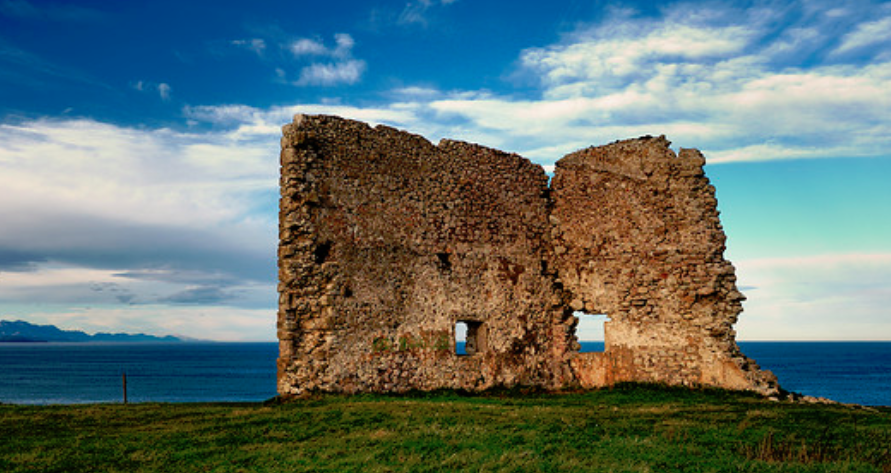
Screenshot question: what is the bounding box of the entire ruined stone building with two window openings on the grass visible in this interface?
[278,115,779,396]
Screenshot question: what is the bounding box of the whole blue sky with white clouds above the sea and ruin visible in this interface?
[0,0,891,341]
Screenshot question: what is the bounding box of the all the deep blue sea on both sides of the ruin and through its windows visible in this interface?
[0,342,891,406]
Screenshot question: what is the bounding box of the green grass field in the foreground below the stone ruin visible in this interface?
[0,386,891,472]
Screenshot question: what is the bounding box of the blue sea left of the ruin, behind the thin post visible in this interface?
[0,343,278,404]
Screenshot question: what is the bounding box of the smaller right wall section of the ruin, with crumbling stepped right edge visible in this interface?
[551,137,775,389]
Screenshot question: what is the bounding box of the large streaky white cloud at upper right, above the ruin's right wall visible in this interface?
[398,4,891,162]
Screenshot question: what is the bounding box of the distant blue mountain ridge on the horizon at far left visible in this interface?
[0,320,183,343]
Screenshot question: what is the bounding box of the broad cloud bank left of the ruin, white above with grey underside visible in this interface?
[0,119,277,320]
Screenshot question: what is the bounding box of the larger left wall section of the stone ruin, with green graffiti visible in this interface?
[279,117,568,394]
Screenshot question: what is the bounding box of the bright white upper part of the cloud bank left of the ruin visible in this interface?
[0,120,276,230]
